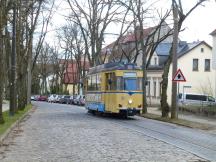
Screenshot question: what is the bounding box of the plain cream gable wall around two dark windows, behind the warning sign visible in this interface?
[167,44,216,104]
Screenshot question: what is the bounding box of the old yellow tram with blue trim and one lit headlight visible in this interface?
[85,63,143,117]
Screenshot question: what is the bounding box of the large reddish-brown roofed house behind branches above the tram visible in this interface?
[101,22,172,64]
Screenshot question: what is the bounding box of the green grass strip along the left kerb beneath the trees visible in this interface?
[0,104,32,136]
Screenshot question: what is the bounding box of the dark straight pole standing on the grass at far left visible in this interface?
[9,1,17,116]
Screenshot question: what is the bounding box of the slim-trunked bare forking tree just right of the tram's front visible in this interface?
[117,0,172,113]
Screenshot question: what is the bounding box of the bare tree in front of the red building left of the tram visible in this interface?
[56,21,88,94]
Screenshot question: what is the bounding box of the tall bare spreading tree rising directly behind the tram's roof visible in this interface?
[67,0,119,66]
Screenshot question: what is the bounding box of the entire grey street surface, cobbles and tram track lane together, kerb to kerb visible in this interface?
[0,102,216,162]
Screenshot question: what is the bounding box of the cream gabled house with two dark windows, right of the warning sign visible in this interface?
[167,41,216,103]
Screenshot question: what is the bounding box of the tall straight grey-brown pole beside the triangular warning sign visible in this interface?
[171,0,179,119]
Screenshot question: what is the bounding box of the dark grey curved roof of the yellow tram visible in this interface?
[88,62,141,74]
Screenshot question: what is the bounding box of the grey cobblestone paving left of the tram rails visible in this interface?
[0,103,207,162]
